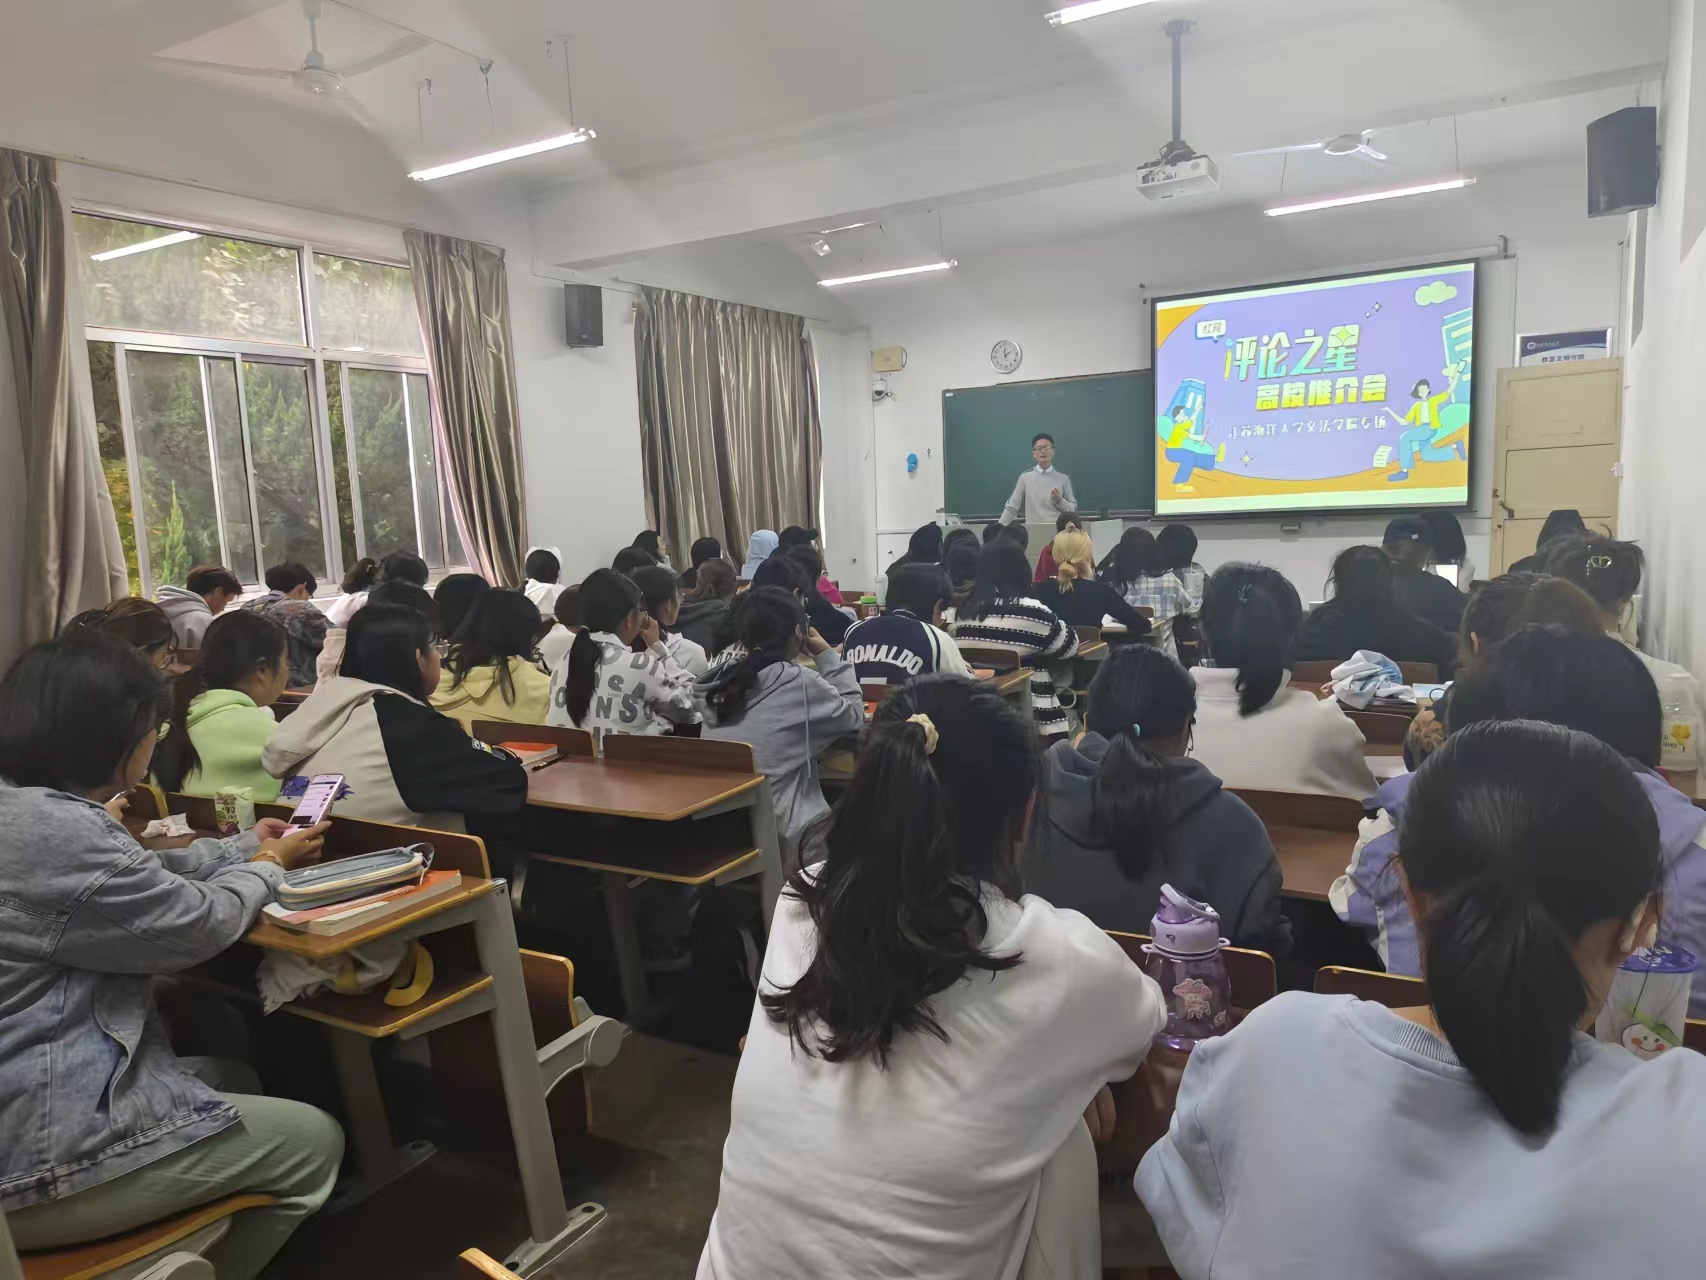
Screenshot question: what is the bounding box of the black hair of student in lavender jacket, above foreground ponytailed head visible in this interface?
[1447,625,1665,768]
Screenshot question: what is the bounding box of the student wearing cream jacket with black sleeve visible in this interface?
[261,604,527,831]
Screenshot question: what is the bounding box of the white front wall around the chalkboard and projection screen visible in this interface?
[850,164,1624,599]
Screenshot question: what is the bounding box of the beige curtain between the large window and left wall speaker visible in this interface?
[403,230,527,587]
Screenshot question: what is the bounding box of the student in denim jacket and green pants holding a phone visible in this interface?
[0,638,343,1280]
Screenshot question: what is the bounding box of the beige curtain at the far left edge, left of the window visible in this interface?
[0,150,126,645]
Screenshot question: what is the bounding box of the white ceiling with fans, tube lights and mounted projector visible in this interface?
[0,0,1668,273]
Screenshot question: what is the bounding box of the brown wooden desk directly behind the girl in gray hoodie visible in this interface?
[515,737,785,1024]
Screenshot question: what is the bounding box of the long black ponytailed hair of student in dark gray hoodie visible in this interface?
[1085,645,1196,879]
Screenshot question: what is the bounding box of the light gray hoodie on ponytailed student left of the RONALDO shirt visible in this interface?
[698,649,865,870]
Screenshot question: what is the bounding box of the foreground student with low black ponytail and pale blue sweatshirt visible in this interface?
[1132,722,1706,1280]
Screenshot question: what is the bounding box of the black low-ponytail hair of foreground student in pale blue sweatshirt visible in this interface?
[1399,727,1662,1137]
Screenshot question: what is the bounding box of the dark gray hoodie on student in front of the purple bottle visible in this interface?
[1025,734,1291,956]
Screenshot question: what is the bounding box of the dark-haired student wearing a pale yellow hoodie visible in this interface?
[428,589,556,734]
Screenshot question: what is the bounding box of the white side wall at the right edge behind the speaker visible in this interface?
[1617,0,1706,671]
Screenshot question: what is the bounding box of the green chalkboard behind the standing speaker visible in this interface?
[942,369,1155,517]
